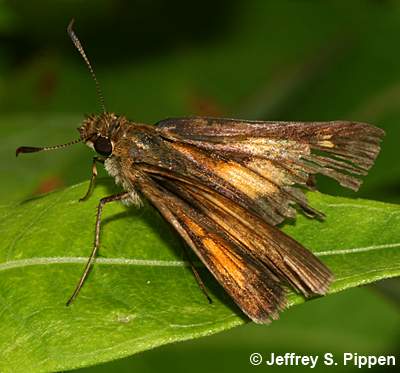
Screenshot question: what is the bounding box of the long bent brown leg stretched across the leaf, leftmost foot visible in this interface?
[67,192,129,306]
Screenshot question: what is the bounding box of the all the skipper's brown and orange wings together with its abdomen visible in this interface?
[130,118,384,322]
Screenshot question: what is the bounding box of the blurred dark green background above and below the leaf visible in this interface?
[0,0,400,372]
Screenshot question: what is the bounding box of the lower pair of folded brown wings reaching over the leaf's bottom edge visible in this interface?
[136,175,332,323]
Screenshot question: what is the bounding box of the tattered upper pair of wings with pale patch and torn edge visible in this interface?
[157,117,384,224]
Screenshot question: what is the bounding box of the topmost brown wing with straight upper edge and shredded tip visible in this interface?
[158,117,384,190]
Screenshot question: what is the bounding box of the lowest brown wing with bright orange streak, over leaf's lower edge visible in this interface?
[138,178,285,323]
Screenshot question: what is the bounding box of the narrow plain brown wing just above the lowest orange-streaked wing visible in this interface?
[152,174,333,296]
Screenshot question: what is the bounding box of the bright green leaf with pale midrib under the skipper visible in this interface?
[0,180,400,372]
